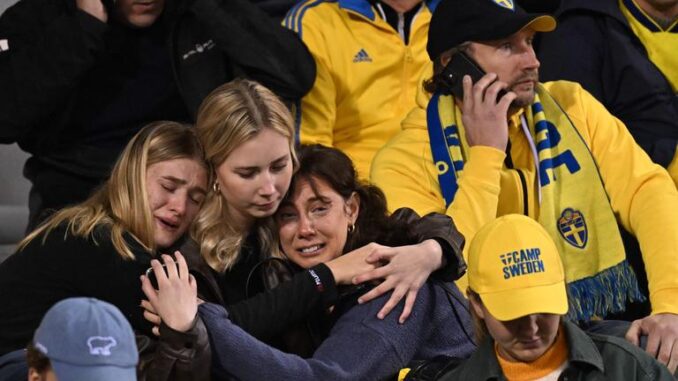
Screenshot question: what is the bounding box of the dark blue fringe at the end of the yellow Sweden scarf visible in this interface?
[567,260,647,321]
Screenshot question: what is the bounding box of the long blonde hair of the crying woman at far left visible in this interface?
[18,122,211,260]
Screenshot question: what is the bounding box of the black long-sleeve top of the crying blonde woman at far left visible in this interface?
[0,226,334,355]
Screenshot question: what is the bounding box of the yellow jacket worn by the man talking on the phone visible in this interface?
[371,69,678,314]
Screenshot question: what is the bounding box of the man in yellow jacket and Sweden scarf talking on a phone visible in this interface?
[371,0,678,371]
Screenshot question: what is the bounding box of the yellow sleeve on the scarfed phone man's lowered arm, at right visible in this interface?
[566,85,678,314]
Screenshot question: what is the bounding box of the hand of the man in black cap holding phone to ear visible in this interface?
[461,73,516,151]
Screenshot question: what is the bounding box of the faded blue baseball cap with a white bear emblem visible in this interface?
[33,298,139,381]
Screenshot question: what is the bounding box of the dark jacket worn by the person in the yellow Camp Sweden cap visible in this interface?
[440,322,673,381]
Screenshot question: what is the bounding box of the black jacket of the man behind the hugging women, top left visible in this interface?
[0,0,315,180]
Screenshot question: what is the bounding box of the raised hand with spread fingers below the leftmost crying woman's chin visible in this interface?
[141,251,198,334]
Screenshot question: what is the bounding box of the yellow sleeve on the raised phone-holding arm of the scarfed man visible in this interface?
[371,101,506,290]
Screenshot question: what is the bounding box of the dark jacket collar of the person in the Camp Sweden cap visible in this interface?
[464,320,605,381]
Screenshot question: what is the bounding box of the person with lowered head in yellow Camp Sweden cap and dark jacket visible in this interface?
[441,214,673,381]
